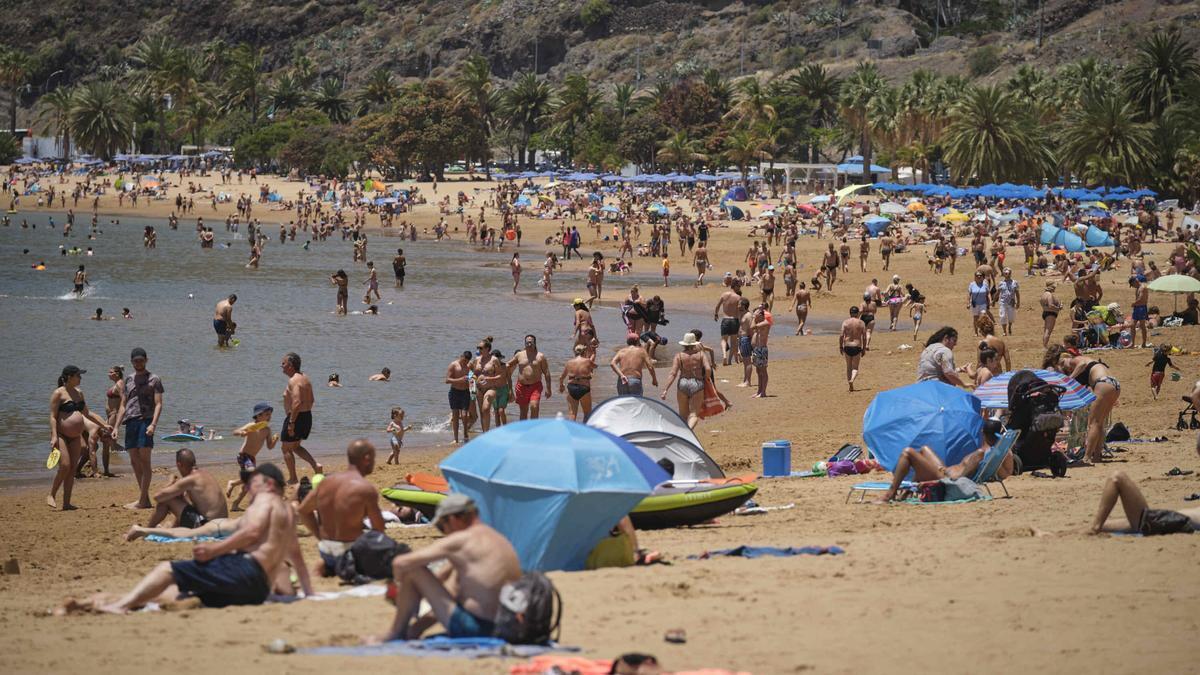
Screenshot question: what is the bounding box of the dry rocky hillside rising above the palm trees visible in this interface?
[0,0,1200,97]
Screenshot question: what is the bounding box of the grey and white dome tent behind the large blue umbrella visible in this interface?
[586,396,725,480]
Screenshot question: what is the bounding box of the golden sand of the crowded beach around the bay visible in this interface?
[0,166,1200,673]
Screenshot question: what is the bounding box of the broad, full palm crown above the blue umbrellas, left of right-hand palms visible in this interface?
[942,85,1051,183]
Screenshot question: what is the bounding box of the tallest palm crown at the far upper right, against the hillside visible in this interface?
[1121,29,1200,119]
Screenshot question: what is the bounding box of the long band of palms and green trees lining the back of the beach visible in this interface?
[0,26,1200,201]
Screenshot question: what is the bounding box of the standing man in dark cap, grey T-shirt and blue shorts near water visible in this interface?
[113,347,163,508]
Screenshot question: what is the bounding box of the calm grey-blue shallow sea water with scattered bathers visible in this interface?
[0,214,710,483]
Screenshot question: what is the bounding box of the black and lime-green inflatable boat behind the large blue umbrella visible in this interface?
[382,480,758,530]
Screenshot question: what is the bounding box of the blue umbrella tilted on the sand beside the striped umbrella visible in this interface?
[863,381,983,471]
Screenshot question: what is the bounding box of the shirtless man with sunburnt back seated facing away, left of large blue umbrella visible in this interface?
[296,438,384,577]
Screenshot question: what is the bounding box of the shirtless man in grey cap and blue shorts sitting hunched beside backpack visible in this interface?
[368,495,521,641]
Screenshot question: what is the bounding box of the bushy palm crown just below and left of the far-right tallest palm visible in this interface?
[1058,92,1154,185]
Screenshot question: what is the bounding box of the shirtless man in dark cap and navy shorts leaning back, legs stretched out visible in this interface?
[90,464,312,614]
